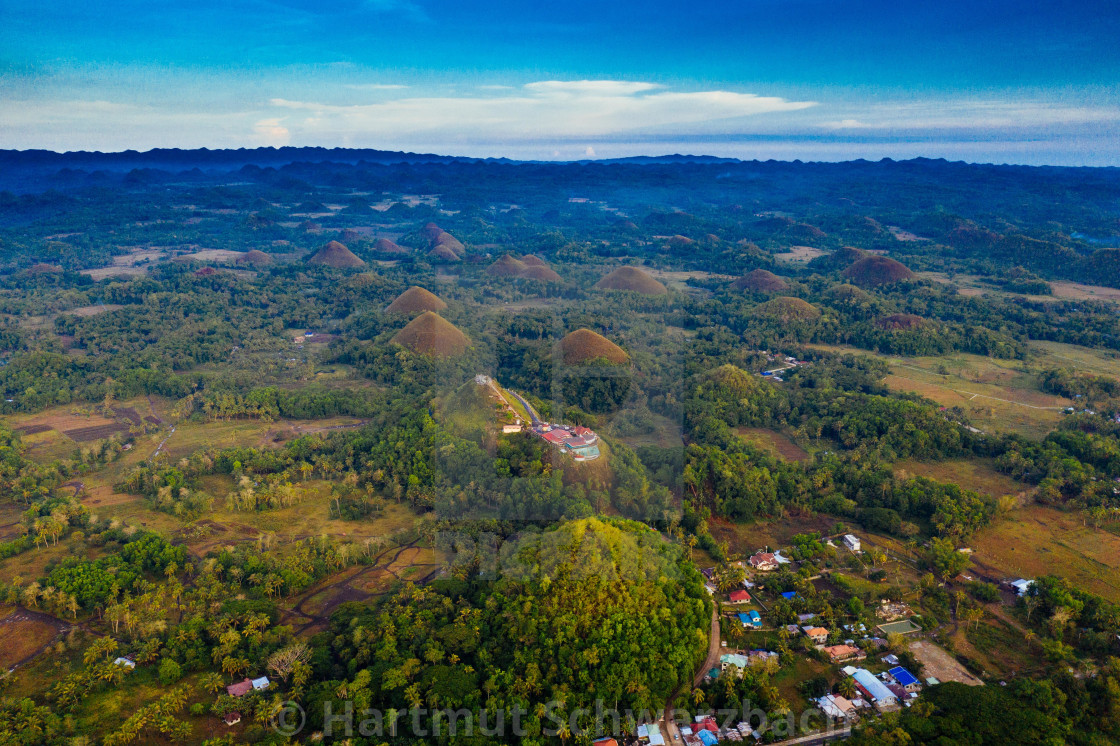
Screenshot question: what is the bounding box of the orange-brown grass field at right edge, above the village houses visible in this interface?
[972,505,1120,602]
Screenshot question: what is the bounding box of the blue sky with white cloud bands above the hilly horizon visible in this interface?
[0,0,1120,165]
